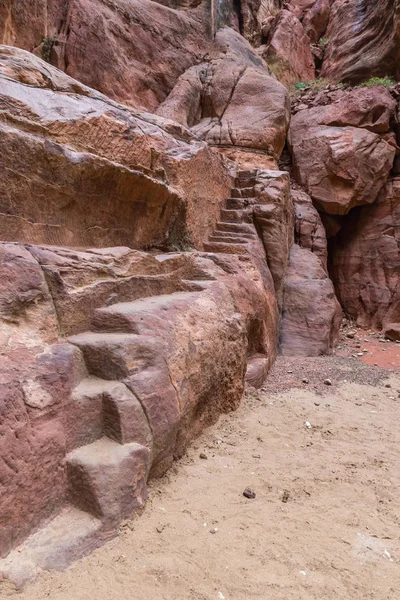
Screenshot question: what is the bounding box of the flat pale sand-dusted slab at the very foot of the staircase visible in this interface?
[0,506,106,589]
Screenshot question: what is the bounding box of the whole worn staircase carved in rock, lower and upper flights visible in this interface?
[0,171,264,585]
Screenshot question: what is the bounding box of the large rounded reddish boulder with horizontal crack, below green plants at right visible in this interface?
[289,88,396,215]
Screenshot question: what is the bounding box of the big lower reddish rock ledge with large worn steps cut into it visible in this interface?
[0,243,278,582]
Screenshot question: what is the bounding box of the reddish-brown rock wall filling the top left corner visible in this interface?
[0,0,211,110]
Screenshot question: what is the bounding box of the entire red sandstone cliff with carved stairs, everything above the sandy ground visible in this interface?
[0,0,400,590]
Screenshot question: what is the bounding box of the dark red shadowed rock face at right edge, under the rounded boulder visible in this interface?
[331,178,400,329]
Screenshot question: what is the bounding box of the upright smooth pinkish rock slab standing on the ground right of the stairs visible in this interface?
[280,244,341,356]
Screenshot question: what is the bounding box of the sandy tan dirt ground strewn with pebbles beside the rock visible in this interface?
[9,333,400,600]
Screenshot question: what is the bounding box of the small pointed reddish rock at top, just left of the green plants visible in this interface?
[262,10,315,84]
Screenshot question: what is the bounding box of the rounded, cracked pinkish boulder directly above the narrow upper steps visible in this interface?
[157,28,290,165]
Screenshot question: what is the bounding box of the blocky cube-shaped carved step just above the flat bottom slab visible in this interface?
[66,437,150,525]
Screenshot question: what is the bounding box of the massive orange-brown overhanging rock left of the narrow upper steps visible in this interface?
[0,46,230,248]
